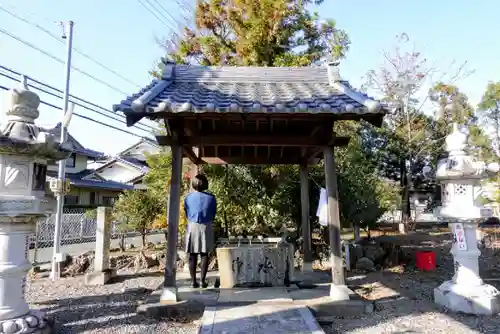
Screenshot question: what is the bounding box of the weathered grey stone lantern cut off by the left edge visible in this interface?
[0,80,71,334]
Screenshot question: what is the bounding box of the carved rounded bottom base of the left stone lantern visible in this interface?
[0,310,53,334]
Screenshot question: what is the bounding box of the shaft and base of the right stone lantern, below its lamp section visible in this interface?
[434,223,500,315]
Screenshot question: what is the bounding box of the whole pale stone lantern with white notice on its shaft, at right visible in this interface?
[434,124,500,315]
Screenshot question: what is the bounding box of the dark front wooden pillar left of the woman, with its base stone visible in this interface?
[160,146,182,302]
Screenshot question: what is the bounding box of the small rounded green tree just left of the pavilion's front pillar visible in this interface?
[113,190,164,246]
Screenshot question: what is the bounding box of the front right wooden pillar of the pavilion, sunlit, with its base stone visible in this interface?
[323,147,349,300]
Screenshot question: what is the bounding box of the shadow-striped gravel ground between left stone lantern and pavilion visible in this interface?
[26,272,197,334]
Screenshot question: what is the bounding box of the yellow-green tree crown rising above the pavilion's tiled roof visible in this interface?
[155,0,350,66]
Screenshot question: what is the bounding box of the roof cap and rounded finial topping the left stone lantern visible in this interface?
[0,77,72,160]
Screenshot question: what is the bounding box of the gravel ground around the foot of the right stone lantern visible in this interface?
[322,231,500,334]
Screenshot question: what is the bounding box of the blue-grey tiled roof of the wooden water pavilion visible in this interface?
[113,63,387,126]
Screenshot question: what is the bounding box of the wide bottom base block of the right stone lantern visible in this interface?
[434,281,500,315]
